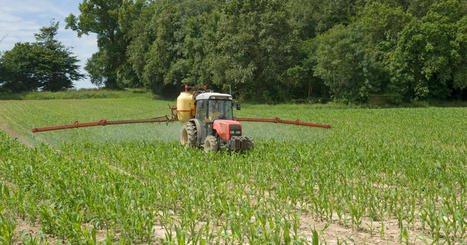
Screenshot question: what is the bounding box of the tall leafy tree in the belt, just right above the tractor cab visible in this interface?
[211,0,297,102]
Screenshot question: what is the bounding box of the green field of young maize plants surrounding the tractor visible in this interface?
[0,96,467,244]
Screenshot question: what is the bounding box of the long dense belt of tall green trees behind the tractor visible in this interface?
[67,0,467,102]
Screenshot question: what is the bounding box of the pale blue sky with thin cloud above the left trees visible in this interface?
[0,0,97,88]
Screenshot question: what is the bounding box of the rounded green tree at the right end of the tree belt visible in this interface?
[389,0,467,99]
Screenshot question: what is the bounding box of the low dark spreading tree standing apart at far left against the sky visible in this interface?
[0,22,83,93]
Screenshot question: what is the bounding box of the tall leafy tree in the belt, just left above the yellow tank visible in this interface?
[140,0,218,92]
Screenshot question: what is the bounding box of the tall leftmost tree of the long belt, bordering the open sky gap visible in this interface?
[65,0,134,88]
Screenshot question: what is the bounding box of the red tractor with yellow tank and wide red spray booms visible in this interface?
[32,86,331,152]
